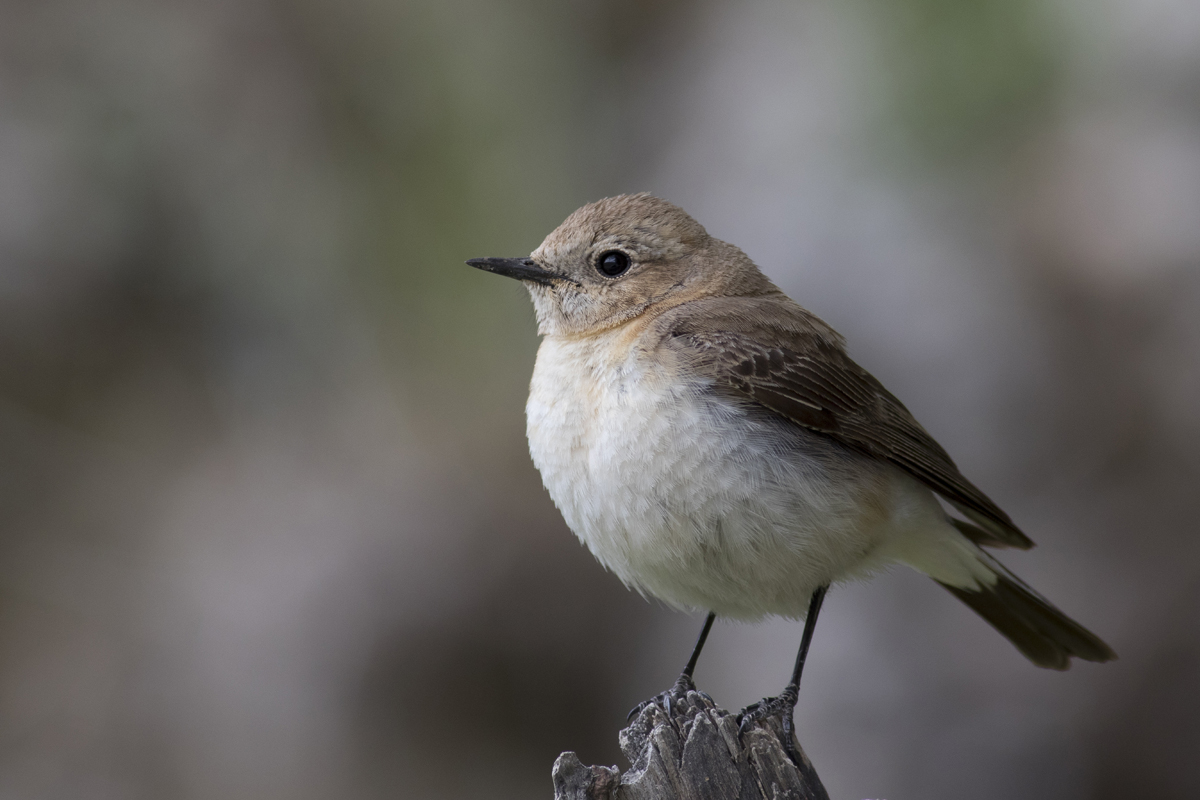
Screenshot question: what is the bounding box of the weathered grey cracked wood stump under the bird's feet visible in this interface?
[553,692,829,800]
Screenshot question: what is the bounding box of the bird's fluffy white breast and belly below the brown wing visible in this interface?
[526,337,941,619]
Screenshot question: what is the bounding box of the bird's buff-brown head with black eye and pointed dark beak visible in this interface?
[467,193,778,336]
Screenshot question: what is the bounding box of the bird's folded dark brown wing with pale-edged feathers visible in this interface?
[665,303,1033,549]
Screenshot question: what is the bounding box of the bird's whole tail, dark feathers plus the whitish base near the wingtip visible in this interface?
[913,525,1117,669]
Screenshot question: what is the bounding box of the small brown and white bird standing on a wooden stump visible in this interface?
[467,193,1116,763]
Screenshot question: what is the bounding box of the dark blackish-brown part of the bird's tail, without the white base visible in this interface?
[938,565,1117,669]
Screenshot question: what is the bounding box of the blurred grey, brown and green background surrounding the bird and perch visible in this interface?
[0,0,1200,800]
